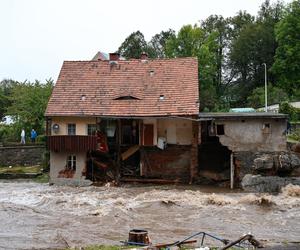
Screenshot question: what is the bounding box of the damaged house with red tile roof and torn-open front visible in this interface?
[45,53,199,185]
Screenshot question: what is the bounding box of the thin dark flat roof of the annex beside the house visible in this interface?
[199,112,287,120]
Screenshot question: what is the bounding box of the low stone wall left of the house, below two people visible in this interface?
[0,145,46,166]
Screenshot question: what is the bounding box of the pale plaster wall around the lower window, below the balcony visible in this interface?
[50,151,86,183]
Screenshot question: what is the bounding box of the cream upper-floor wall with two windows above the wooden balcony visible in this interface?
[51,117,96,135]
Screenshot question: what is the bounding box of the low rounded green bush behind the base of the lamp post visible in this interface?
[247,84,289,108]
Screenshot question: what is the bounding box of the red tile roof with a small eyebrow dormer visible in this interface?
[46,58,199,117]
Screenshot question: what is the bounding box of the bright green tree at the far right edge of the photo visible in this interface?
[272,0,300,97]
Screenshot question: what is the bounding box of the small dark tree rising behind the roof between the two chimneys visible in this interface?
[118,30,149,59]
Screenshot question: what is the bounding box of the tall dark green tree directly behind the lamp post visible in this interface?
[229,0,283,106]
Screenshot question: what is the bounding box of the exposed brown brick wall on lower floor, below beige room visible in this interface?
[141,145,191,181]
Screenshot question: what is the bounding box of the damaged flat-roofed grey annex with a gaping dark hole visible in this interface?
[199,112,292,188]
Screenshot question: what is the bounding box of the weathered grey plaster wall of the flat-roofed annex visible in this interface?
[215,119,286,151]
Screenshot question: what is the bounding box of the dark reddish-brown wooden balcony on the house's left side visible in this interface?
[47,135,97,152]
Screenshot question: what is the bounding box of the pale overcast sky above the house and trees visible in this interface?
[0,0,290,81]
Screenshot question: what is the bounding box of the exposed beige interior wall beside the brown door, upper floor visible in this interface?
[157,119,193,145]
